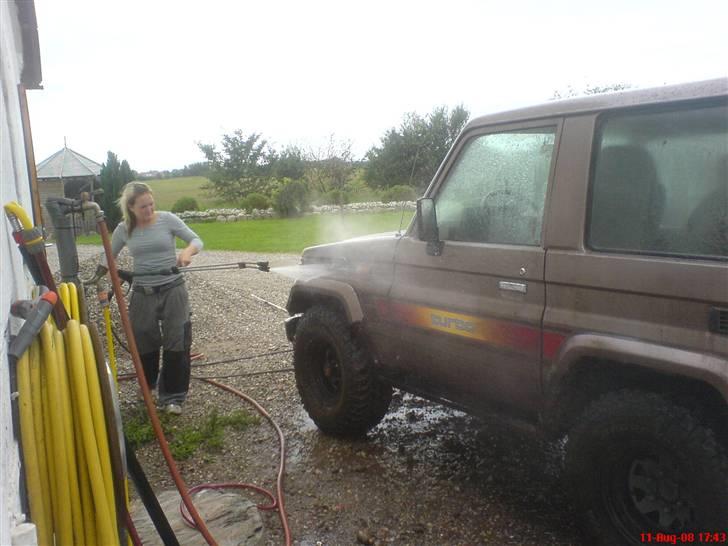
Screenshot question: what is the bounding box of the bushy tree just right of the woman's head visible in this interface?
[197,129,275,201]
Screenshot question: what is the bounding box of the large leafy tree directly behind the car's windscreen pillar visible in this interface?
[365,105,470,190]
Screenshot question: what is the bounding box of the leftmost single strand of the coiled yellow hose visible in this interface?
[17,344,53,546]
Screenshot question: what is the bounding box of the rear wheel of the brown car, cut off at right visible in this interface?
[566,391,728,545]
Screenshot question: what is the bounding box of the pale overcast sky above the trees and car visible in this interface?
[25,0,728,171]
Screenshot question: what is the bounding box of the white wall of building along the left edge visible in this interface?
[0,1,38,545]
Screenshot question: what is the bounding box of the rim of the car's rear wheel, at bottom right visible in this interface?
[602,449,695,544]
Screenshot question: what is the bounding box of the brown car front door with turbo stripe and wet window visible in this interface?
[370,120,560,414]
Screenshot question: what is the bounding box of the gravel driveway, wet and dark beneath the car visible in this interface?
[67,247,581,546]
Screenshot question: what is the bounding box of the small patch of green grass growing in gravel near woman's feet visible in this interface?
[124,407,260,461]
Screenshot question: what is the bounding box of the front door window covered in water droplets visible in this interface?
[435,127,556,245]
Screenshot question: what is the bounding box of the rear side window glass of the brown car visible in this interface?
[587,104,728,258]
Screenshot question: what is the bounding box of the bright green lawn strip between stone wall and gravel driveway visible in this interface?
[76,211,413,254]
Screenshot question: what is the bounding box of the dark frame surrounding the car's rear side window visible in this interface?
[584,97,728,262]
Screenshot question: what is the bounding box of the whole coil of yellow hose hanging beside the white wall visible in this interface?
[13,283,119,546]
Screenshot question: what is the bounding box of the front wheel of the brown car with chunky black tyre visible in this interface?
[293,306,392,436]
